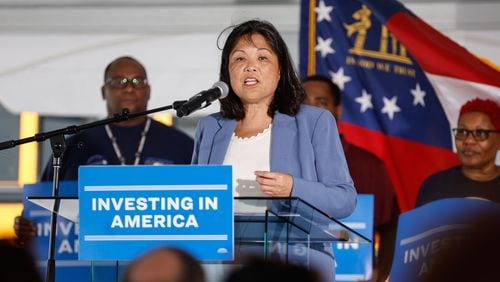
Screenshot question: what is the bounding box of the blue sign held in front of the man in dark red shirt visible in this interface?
[333,194,373,281]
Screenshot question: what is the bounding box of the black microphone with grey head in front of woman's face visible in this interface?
[176,81,229,117]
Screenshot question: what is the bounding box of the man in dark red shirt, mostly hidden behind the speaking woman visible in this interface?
[302,75,400,281]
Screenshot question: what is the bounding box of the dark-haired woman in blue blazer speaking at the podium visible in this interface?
[192,20,357,281]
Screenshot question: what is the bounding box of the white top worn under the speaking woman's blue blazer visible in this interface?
[223,125,271,213]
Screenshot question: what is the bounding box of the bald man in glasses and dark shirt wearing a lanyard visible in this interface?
[14,57,194,242]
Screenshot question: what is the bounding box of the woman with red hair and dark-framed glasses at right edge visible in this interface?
[415,99,500,207]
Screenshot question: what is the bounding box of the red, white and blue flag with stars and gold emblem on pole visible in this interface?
[300,0,500,211]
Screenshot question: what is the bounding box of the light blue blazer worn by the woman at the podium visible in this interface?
[192,106,357,218]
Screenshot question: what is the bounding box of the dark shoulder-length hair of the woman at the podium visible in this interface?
[219,20,305,120]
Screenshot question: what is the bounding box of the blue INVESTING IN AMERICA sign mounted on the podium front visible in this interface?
[78,165,234,261]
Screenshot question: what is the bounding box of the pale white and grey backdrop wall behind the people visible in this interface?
[0,0,500,116]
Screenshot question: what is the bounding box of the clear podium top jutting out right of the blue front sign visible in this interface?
[234,197,371,252]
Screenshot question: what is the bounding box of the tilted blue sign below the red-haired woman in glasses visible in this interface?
[390,198,500,282]
